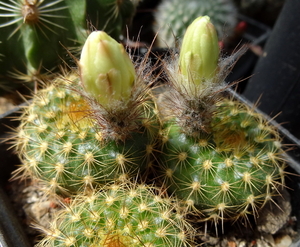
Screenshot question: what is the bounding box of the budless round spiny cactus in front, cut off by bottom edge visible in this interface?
[37,184,194,247]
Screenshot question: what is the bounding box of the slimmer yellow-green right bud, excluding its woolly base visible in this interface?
[179,16,220,85]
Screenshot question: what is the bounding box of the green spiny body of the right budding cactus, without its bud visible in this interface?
[160,100,284,219]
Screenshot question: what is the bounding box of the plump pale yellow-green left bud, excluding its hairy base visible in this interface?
[79,31,136,106]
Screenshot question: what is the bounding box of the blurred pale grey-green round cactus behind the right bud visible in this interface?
[155,0,237,47]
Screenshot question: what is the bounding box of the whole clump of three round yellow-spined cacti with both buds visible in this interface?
[14,16,285,247]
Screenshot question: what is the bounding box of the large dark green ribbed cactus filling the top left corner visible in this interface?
[0,0,136,99]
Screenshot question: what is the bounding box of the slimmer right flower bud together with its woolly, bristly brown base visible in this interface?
[159,16,226,135]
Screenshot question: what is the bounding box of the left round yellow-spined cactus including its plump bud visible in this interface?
[15,31,158,194]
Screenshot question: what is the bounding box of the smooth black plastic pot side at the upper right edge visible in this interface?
[243,0,300,143]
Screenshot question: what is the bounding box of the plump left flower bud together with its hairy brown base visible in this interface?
[79,31,157,141]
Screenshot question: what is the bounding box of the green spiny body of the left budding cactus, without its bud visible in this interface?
[17,78,155,193]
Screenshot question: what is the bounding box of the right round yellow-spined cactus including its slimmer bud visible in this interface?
[158,16,285,224]
